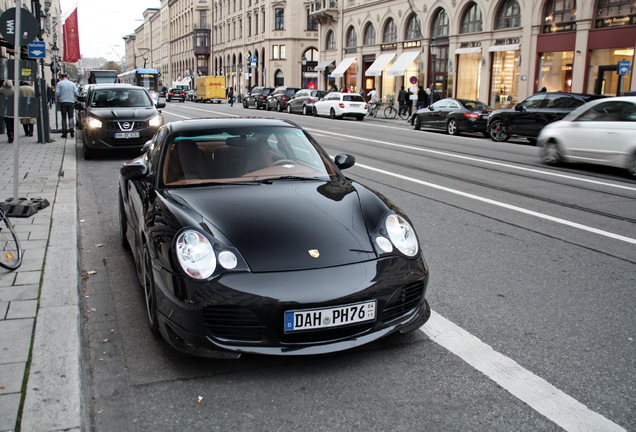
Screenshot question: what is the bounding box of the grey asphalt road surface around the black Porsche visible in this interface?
[77,102,636,431]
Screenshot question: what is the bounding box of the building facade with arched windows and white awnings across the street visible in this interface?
[310,0,636,108]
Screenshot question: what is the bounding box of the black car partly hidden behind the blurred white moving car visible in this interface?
[488,92,603,144]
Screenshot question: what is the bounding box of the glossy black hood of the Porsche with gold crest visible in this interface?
[165,181,377,272]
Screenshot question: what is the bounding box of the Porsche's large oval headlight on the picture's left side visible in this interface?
[175,230,216,279]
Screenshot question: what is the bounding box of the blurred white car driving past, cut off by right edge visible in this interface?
[537,96,636,177]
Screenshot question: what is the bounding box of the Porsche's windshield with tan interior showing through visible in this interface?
[162,127,336,186]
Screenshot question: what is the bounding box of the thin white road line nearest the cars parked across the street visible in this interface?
[306,128,636,191]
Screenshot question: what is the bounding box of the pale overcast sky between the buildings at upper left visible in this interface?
[60,0,160,62]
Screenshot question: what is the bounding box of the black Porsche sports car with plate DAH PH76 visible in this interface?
[119,118,430,358]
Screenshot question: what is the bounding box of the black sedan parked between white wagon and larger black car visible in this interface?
[411,98,492,136]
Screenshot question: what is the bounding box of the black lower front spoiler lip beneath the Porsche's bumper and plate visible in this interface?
[158,300,431,359]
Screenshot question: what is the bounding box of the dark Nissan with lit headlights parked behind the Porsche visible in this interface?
[78,84,166,159]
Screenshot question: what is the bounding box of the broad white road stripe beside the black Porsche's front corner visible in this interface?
[420,311,625,432]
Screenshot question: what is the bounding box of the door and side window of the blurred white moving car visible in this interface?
[567,101,636,166]
